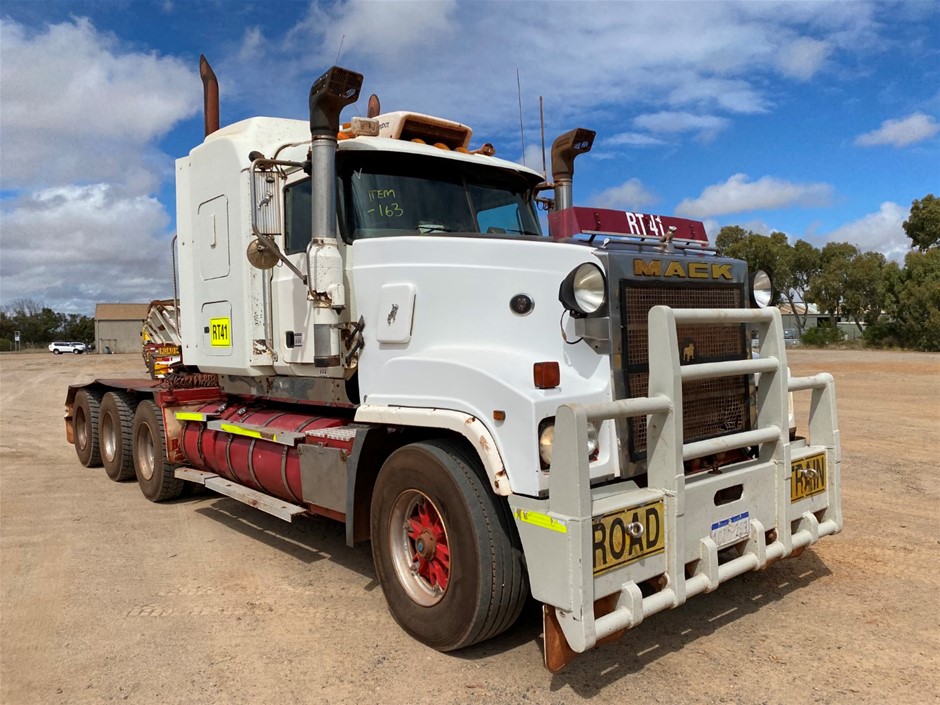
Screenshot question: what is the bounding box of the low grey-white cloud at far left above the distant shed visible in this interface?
[0,184,172,314]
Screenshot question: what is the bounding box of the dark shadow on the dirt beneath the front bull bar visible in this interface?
[455,549,831,698]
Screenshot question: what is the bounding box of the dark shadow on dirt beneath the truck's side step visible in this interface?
[189,495,379,592]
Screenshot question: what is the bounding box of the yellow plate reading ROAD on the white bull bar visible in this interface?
[593,500,666,575]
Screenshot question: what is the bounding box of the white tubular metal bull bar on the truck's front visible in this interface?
[509,306,842,670]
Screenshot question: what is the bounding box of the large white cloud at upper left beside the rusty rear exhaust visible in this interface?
[0,19,201,189]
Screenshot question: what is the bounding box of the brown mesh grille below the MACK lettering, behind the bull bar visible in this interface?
[620,279,750,462]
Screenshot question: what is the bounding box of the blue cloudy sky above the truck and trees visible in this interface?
[0,0,940,315]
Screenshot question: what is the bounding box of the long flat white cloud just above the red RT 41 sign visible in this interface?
[676,174,832,218]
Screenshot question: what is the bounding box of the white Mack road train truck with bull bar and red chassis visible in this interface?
[66,57,842,670]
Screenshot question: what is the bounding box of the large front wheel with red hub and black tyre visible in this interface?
[371,441,528,651]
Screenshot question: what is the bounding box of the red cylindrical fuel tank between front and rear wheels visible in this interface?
[180,402,348,504]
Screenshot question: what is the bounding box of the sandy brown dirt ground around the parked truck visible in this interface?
[0,350,940,705]
